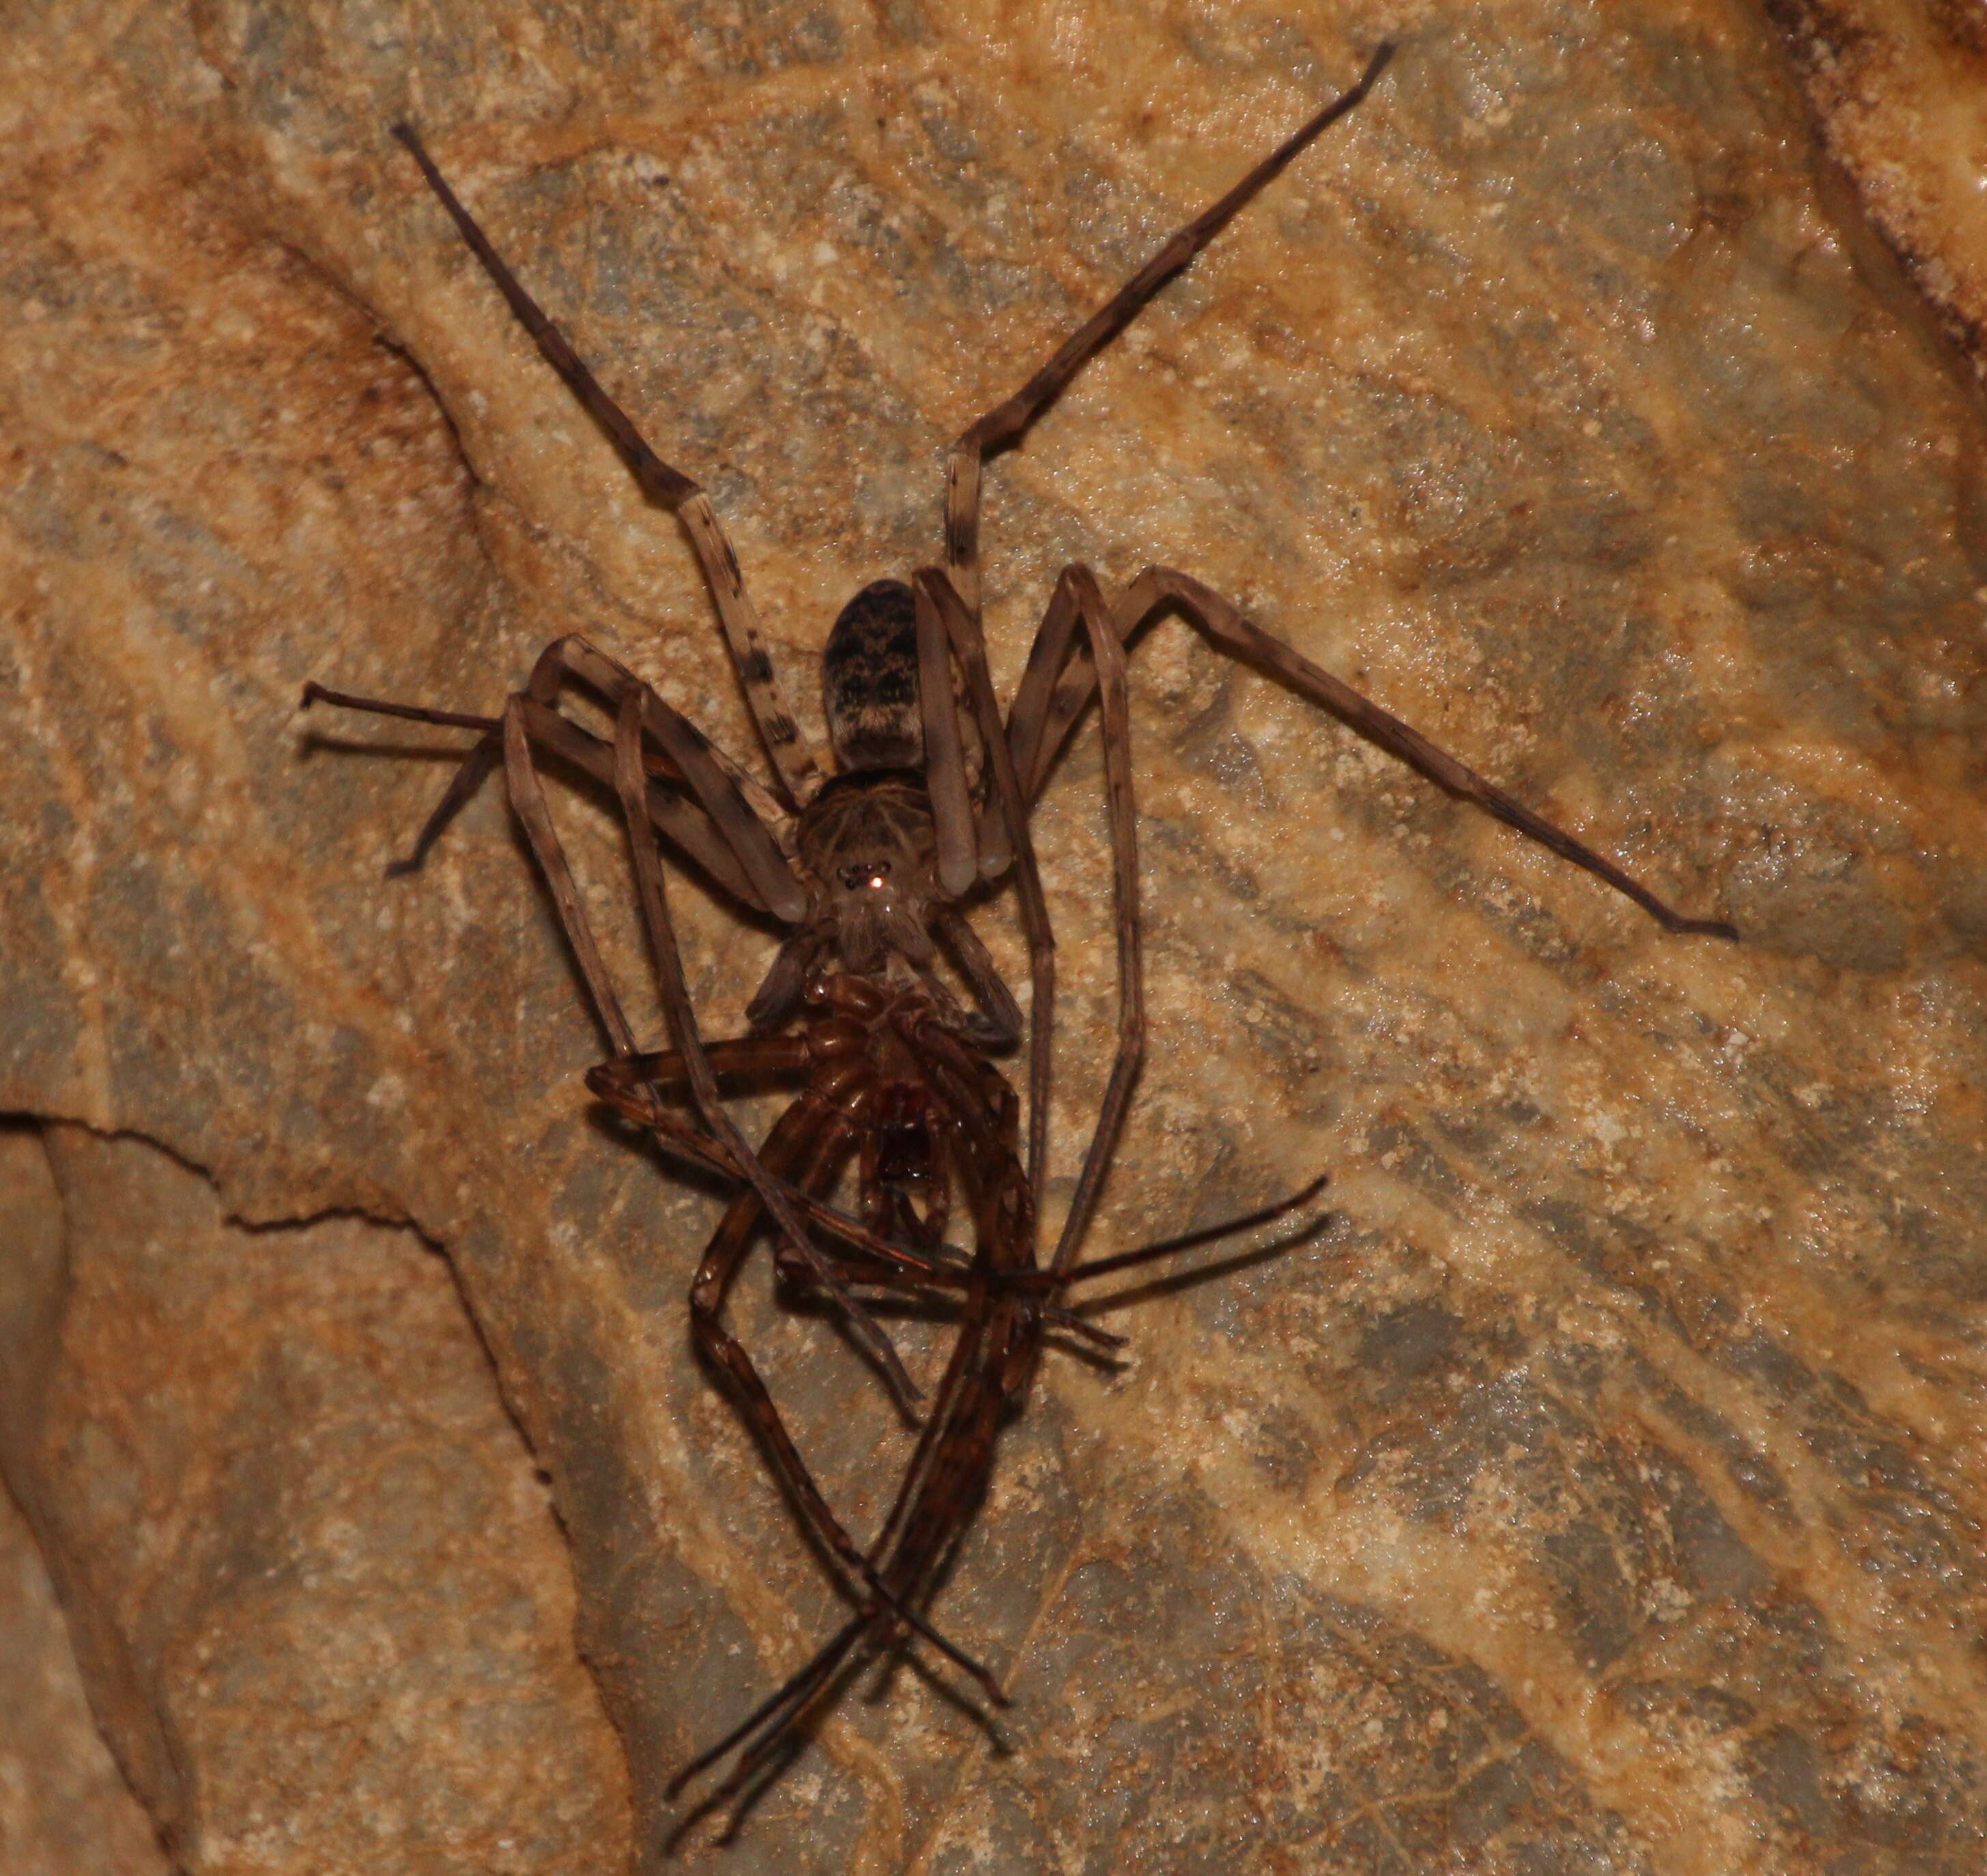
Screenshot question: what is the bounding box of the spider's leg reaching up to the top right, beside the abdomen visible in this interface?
[946,46,1393,622]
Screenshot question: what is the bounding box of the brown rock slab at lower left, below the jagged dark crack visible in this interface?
[0,1127,628,1876]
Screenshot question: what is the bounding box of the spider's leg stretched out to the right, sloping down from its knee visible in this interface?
[1007,566,1739,940]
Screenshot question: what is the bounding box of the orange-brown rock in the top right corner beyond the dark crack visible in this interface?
[1769,0,1987,372]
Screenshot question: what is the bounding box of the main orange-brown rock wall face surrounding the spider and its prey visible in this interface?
[0,0,1987,1876]
